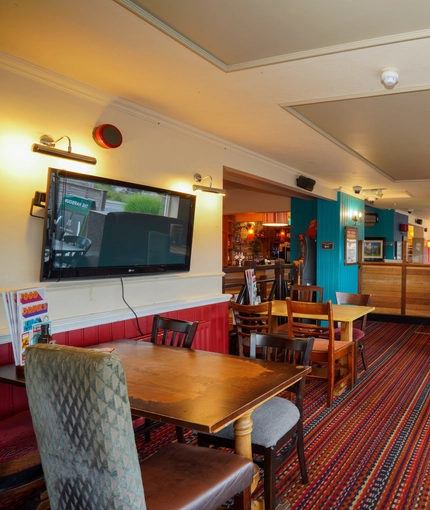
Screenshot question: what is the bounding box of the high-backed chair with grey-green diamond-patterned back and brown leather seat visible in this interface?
[25,344,254,510]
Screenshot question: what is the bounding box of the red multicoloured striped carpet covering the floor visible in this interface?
[4,322,430,510]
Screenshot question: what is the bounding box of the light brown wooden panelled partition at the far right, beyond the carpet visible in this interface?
[358,261,430,317]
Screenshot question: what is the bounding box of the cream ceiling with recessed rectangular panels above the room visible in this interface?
[0,0,430,219]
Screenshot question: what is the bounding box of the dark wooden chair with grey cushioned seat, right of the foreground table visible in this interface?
[197,333,314,509]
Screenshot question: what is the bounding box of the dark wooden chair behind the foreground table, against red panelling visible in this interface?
[133,315,199,443]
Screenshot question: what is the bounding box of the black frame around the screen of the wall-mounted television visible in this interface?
[40,168,196,282]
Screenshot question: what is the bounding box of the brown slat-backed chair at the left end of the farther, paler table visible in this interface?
[231,301,272,356]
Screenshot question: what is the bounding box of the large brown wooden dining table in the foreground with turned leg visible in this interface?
[0,340,311,509]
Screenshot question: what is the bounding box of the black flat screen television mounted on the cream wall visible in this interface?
[41,168,195,281]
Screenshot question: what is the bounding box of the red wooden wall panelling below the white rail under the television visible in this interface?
[0,302,228,419]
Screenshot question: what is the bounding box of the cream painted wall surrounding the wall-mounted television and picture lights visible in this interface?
[0,55,332,342]
